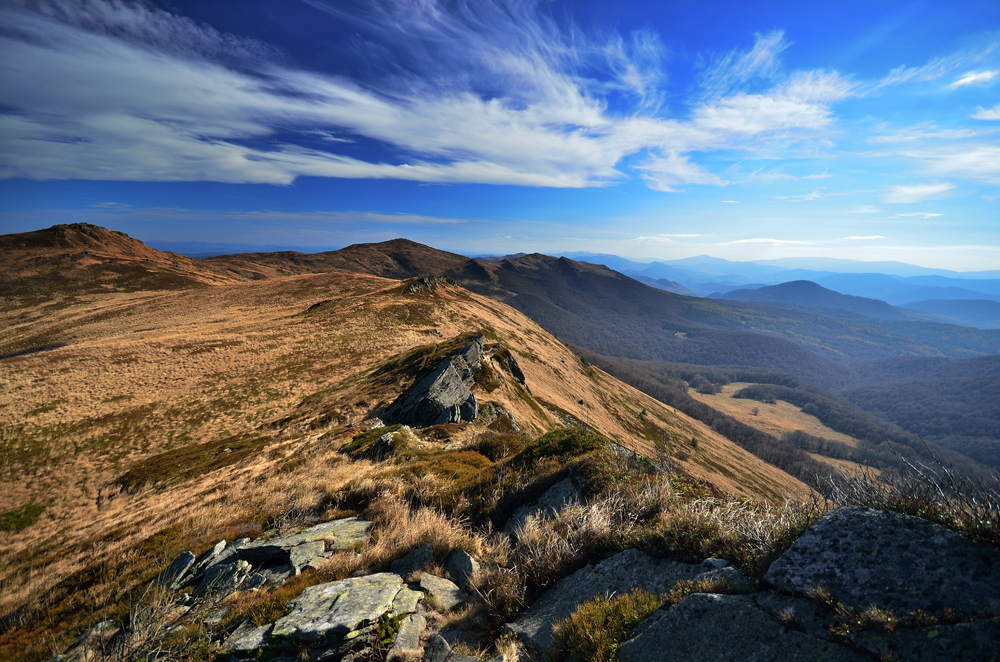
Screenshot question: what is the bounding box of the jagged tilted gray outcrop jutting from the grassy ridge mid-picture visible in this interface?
[383,338,483,426]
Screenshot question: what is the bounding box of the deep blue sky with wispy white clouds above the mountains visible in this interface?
[0,0,1000,271]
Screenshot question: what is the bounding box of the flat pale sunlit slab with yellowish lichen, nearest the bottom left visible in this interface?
[271,572,403,643]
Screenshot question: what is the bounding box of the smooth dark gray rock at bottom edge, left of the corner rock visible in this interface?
[618,593,868,662]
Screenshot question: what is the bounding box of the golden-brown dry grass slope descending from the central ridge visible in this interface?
[0,235,809,652]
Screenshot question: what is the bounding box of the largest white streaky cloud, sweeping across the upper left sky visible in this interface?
[0,0,852,191]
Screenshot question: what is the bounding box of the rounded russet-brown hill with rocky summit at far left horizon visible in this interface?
[0,223,233,301]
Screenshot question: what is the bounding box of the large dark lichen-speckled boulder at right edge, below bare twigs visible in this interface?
[765,506,1000,614]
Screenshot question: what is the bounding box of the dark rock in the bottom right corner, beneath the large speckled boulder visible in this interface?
[850,618,1000,662]
